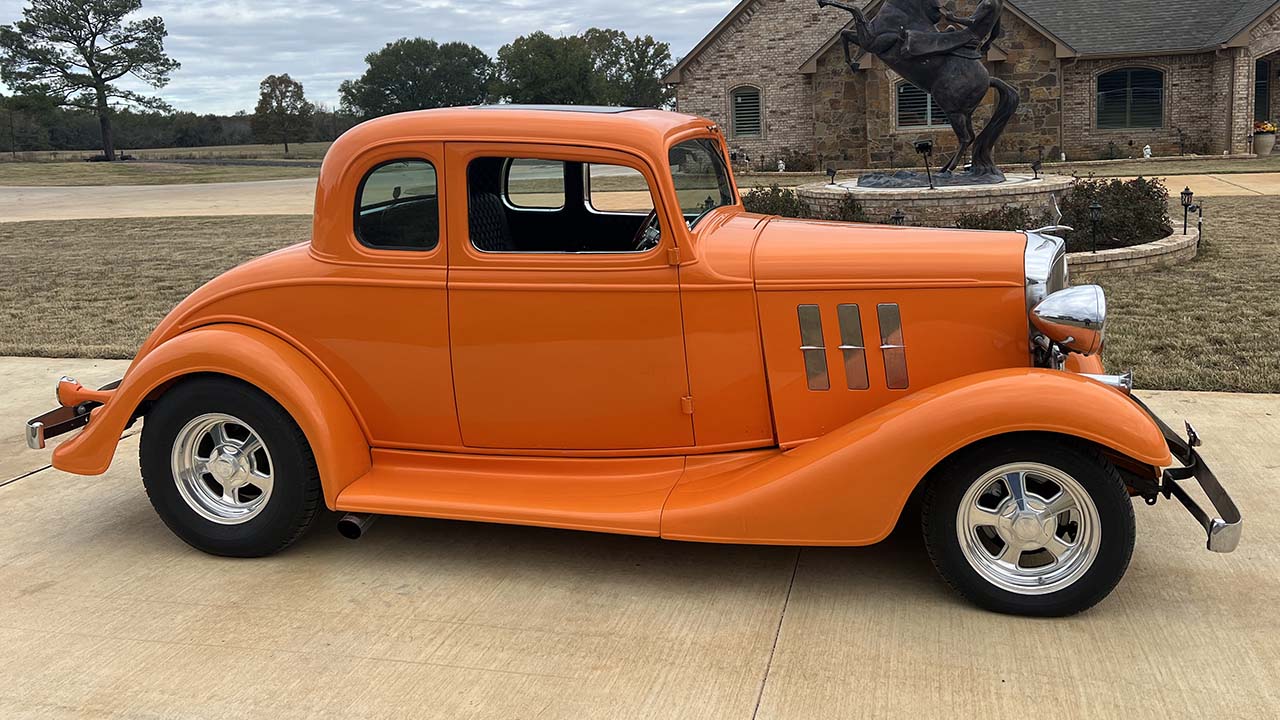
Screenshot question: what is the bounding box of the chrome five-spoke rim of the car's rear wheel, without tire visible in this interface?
[170,413,274,525]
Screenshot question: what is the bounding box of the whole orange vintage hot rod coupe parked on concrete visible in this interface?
[27,106,1240,615]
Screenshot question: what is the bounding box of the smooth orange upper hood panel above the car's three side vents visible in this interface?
[754,219,1027,291]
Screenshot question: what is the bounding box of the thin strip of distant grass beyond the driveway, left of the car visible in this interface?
[0,161,320,187]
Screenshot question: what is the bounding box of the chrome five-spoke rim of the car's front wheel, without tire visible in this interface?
[956,462,1102,594]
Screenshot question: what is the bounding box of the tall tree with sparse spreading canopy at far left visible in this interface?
[0,0,180,160]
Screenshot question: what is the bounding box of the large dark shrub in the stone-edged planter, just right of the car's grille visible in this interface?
[1061,178,1172,252]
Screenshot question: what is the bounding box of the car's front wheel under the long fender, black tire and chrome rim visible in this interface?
[922,436,1137,618]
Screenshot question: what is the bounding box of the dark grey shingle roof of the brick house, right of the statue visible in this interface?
[1010,0,1277,55]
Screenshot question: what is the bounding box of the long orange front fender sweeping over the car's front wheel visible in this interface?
[662,369,1172,546]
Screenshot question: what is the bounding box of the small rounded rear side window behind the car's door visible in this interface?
[356,159,440,251]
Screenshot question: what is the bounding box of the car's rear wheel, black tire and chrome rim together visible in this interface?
[138,377,323,557]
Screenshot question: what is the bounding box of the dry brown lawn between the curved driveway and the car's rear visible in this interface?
[0,215,311,357]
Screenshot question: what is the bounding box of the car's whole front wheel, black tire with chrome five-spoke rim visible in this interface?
[923,437,1135,616]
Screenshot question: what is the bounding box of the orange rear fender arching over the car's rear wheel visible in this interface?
[54,324,371,507]
